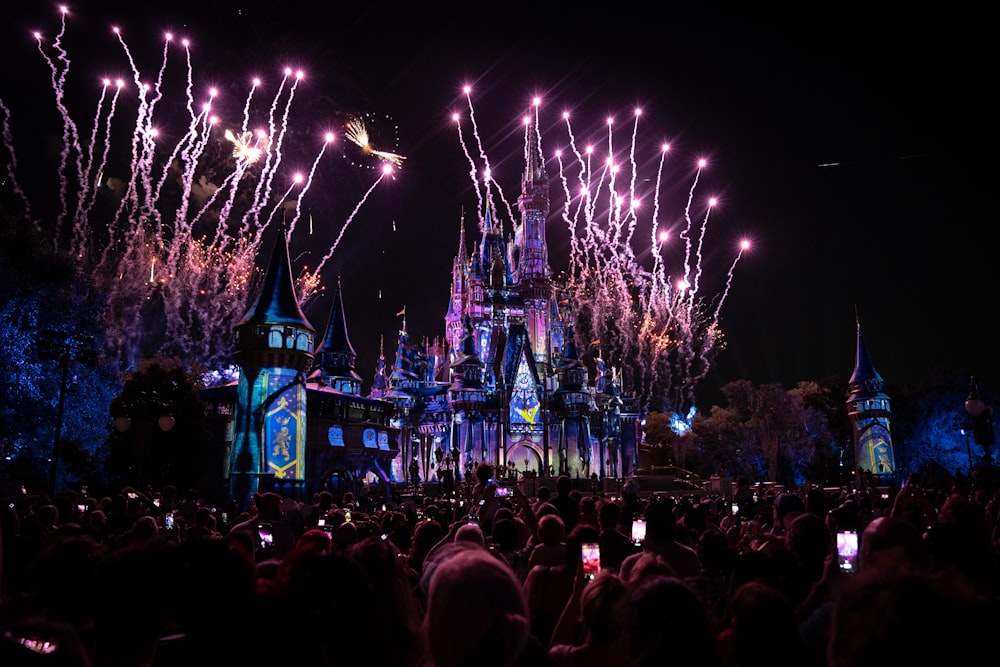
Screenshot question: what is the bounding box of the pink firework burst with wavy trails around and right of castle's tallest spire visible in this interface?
[453,88,749,414]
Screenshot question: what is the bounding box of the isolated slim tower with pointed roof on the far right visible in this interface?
[847,321,896,485]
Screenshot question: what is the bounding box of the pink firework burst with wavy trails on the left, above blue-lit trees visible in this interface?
[0,11,392,374]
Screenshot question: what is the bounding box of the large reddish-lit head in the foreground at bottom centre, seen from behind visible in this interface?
[422,547,531,667]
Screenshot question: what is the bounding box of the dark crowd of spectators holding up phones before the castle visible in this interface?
[0,464,1000,667]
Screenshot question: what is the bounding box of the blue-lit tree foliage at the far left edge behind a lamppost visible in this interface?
[0,218,118,496]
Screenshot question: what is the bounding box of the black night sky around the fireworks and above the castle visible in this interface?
[0,2,1000,408]
